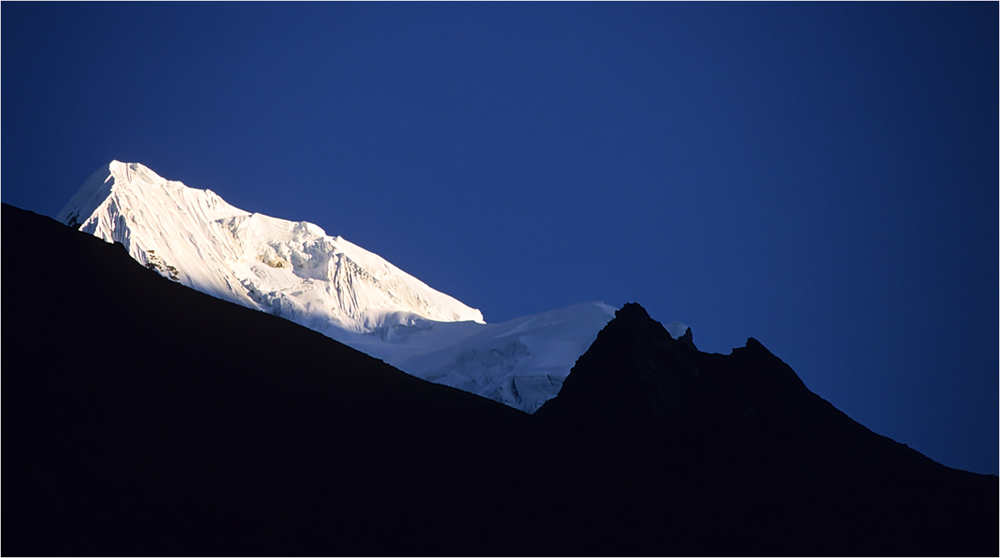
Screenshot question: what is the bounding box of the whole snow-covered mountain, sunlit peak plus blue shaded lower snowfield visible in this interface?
[56,161,615,413]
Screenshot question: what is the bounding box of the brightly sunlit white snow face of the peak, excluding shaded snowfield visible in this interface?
[57,161,483,333]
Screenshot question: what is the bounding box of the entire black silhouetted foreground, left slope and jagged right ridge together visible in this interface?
[2,205,998,555]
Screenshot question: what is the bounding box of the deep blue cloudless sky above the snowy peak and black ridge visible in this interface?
[0,2,1000,473]
